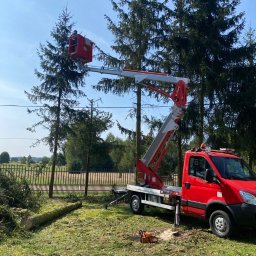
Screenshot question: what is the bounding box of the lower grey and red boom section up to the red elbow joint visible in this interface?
[136,80,187,189]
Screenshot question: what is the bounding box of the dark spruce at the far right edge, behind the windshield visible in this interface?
[225,28,256,167]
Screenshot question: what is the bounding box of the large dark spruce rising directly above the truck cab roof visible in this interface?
[166,0,244,144]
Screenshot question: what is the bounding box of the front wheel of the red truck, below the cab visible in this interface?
[209,210,234,238]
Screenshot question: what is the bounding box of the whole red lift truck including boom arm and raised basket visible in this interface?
[69,35,256,237]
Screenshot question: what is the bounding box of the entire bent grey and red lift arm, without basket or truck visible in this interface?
[78,66,189,189]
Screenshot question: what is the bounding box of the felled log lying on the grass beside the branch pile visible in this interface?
[21,202,82,230]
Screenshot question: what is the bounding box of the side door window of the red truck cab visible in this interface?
[189,156,210,179]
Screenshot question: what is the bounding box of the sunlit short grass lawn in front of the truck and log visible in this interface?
[0,198,256,256]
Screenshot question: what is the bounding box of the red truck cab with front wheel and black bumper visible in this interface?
[181,149,256,237]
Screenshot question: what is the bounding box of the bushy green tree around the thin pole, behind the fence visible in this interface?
[65,103,113,172]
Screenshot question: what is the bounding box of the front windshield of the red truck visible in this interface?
[211,156,256,180]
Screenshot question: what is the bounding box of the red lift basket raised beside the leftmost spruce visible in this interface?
[68,34,93,63]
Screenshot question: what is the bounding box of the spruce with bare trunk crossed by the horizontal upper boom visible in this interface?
[97,0,167,182]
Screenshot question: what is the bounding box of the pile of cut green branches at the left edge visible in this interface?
[0,169,40,237]
